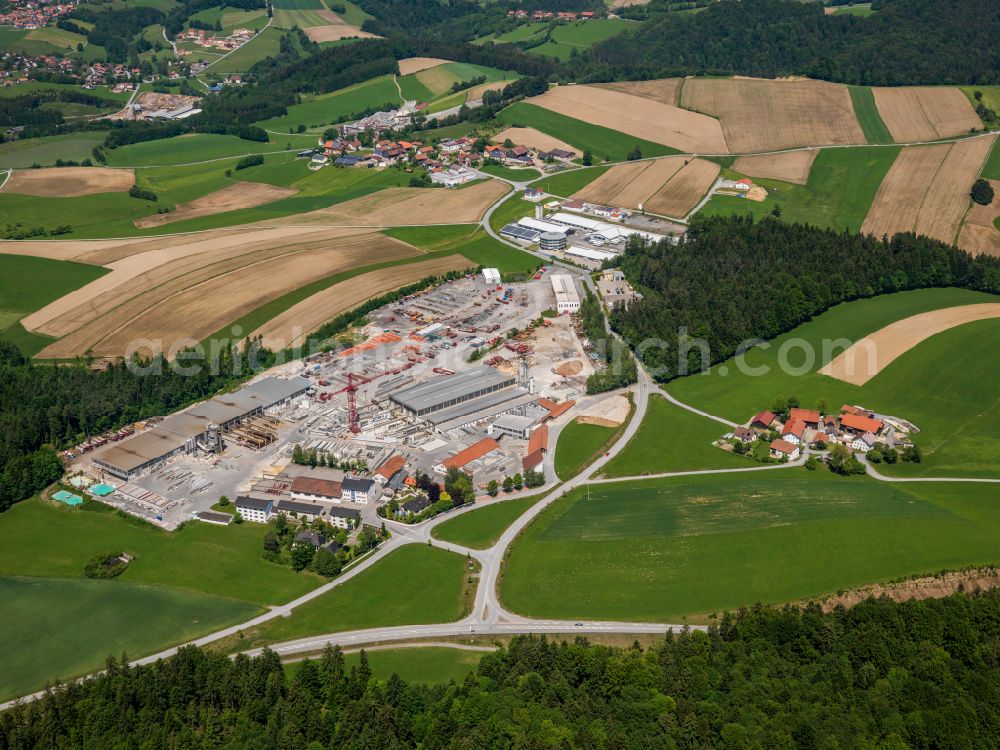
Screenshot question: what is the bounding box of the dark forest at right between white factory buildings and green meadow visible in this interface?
[611,217,1000,379]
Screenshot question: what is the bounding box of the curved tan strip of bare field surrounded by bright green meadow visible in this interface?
[819,302,1000,385]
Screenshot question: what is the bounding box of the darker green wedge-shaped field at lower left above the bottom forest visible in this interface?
[0,576,260,699]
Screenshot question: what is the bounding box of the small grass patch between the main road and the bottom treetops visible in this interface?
[285,646,485,685]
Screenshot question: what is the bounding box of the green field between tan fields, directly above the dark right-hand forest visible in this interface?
[700,146,900,232]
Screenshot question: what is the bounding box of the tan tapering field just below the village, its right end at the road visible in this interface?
[282,180,510,227]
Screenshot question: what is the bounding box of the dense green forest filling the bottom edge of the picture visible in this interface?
[0,590,1000,750]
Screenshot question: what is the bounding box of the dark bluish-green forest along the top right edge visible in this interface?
[576,0,1000,86]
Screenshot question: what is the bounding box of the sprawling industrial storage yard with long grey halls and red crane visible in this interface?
[72,269,594,529]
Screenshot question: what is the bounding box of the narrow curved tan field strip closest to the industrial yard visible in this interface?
[250,255,475,351]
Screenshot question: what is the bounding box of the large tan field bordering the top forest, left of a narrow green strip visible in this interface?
[681,78,867,154]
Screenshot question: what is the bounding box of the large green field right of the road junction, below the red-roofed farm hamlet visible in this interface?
[500,476,1000,622]
